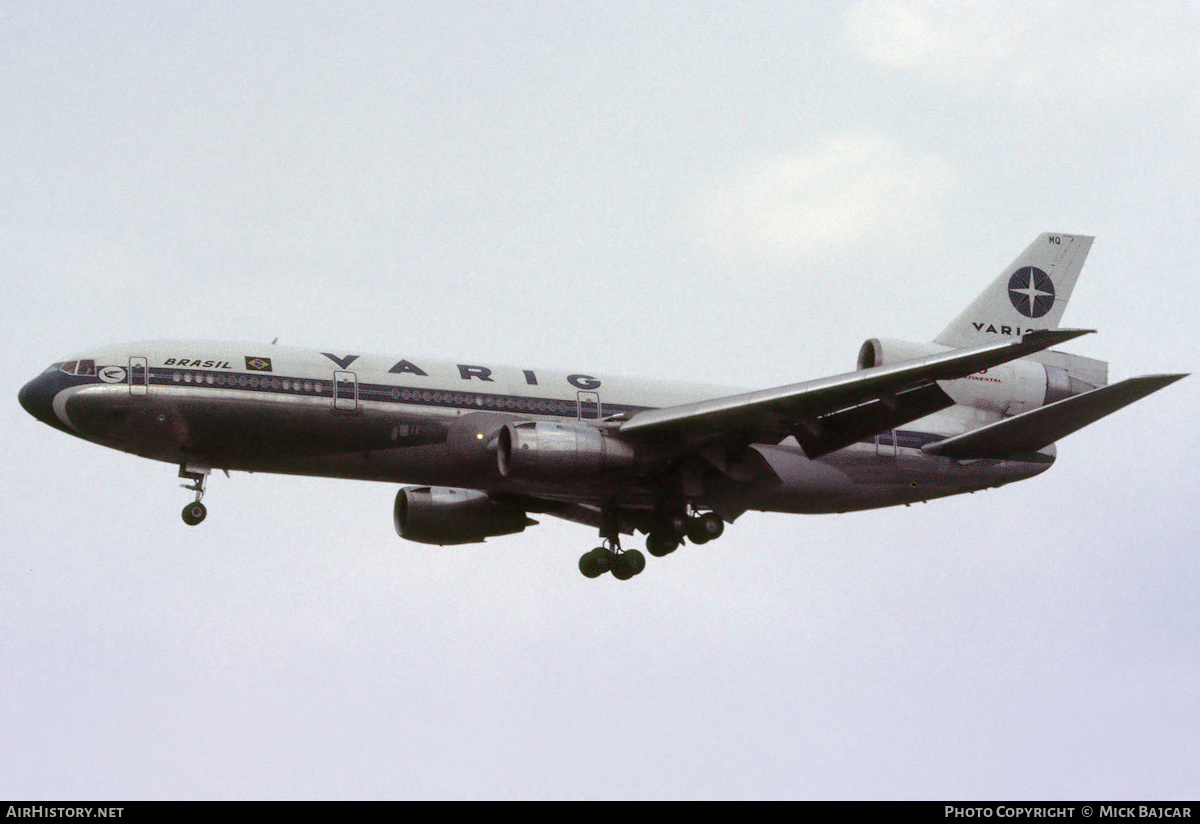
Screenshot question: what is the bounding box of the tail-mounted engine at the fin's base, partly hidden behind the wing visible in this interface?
[858,338,1105,415]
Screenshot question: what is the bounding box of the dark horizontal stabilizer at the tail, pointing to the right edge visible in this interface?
[922,374,1187,458]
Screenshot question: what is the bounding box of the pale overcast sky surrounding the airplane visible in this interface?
[0,0,1200,799]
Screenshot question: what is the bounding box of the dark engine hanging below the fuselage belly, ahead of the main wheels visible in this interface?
[394,487,536,546]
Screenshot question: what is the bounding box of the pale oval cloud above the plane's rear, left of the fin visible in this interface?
[701,134,959,265]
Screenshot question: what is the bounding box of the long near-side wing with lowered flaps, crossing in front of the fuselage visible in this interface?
[619,329,1091,458]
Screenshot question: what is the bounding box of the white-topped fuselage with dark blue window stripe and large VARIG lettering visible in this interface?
[22,341,1054,512]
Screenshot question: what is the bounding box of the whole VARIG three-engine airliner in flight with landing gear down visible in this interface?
[19,233,1186,579]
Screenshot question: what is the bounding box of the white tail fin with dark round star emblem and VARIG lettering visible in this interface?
[934,233,1094,348]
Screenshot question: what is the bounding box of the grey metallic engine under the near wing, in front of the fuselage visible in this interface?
[498,421,637,481]
